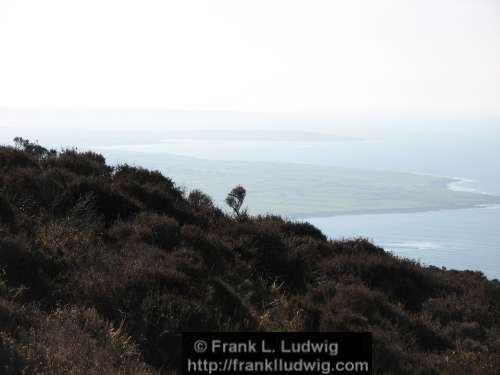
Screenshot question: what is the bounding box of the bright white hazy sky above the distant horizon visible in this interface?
[0,0,500,116]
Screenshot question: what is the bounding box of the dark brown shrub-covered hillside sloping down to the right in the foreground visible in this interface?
[0,139,500,375]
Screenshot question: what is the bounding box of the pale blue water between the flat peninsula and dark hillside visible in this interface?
[307,206,500,279]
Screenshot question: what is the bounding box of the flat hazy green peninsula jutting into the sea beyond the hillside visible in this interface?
[99,147,500,218]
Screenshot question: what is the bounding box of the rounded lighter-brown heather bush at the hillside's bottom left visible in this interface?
[22,307,154,375]
